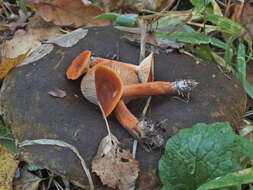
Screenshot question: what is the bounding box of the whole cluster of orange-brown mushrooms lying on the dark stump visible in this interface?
[66,50,198,148]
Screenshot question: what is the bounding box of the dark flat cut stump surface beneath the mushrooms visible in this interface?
[0,27,246,190]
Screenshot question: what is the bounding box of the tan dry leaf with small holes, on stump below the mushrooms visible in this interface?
[92,135,139,189]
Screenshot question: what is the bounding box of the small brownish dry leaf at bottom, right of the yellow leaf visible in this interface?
[13,168,43,190]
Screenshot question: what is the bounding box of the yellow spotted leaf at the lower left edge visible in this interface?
[0,145,18,190]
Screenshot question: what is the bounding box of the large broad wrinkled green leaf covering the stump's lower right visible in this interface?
[159,122,248,190]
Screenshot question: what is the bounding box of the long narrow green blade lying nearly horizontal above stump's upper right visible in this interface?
[155,32,226,49]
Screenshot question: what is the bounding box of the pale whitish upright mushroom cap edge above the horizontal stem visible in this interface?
[137,52,154,83]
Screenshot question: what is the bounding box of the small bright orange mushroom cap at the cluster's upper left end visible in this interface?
[66,50,91,80]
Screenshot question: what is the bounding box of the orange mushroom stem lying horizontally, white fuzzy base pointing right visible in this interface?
[123,80,198,98]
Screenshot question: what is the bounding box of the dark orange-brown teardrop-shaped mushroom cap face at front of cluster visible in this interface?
[95,65,123,116]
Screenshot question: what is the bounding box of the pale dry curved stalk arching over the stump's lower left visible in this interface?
[19,139,94,190]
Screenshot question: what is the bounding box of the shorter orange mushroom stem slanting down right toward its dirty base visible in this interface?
[114,100,144,139]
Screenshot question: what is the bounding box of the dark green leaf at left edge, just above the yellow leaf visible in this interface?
[0,125,19,153]
